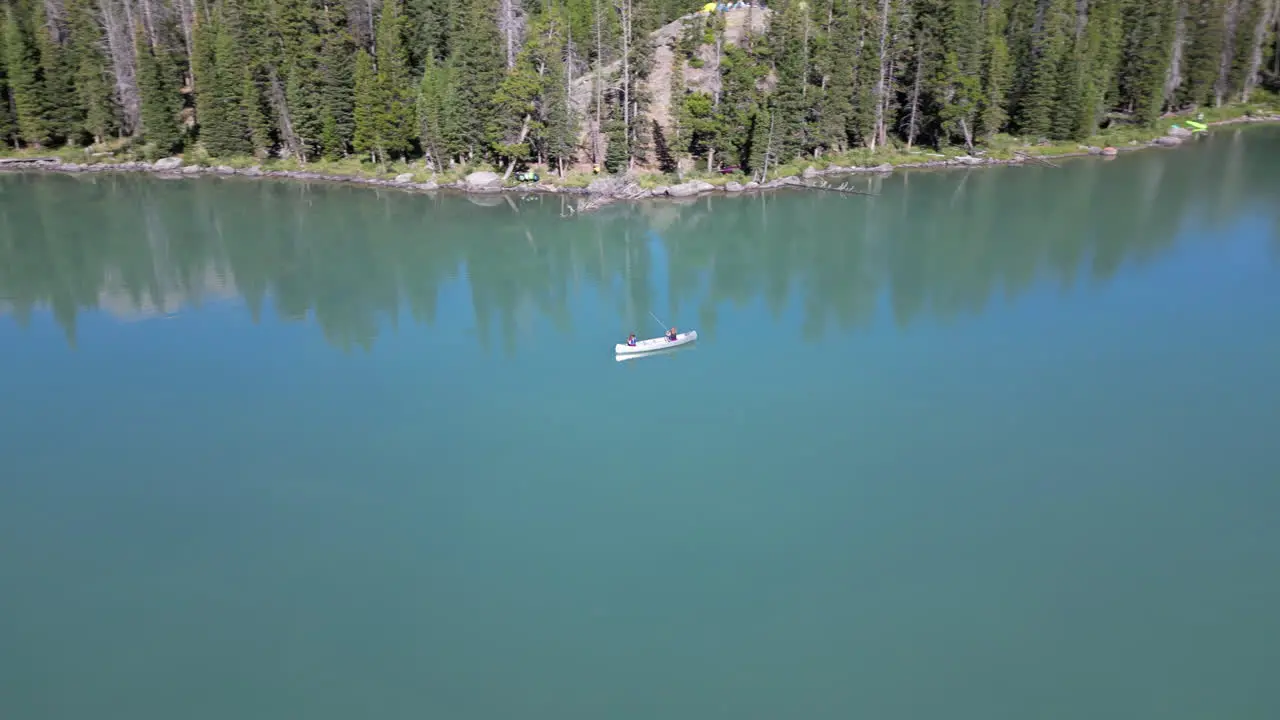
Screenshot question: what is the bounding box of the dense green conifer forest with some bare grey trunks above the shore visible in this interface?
[0,0,1280,173]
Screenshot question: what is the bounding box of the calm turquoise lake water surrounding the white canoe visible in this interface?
[0,128,1280,720]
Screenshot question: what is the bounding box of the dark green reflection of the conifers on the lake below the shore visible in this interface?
[0,128,1280,354]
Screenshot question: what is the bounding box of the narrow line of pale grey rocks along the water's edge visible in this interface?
[0,115,1280,206]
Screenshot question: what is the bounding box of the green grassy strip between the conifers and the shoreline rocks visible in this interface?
[0,92,1280,190]
